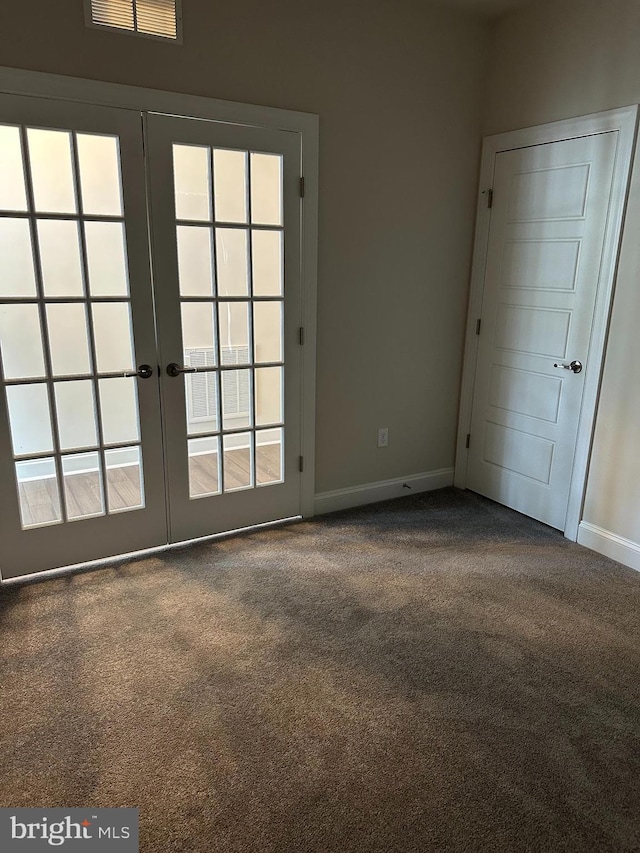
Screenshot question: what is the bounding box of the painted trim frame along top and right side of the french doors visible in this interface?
[0,66,319,517]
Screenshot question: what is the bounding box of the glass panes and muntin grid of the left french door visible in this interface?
[0,124,145,529]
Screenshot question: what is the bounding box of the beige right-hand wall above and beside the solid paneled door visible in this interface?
[485,0,640,543]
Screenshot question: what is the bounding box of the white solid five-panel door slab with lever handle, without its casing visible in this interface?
[467,132,618,530]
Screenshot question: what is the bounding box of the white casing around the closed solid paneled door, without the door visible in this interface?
[454,105,638,542]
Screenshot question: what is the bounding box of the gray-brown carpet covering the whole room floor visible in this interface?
[0,489,640,853]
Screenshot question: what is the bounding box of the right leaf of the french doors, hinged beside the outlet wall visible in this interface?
[147,114,302,542]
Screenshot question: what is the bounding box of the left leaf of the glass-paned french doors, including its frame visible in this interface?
[0,96,166,578]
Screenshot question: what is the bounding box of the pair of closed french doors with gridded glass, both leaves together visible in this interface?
[0,96,301,578]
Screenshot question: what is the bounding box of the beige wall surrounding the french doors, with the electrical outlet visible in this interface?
[0,0,486,491]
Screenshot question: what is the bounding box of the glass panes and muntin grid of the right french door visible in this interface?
[173,143,284,499]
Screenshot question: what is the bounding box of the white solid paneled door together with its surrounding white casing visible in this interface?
[456,108,636,539]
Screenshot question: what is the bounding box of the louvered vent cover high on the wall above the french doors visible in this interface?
[85,0,181,41]
